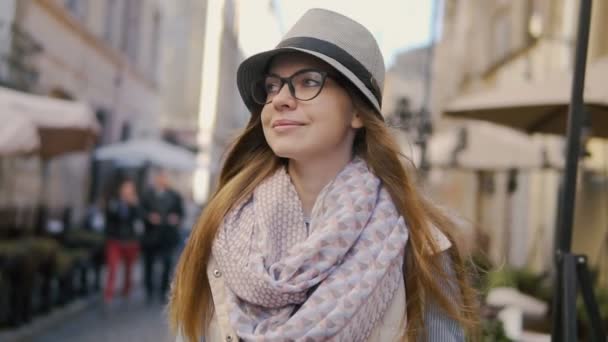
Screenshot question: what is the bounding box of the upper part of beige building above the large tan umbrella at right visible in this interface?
[433,0,608,110]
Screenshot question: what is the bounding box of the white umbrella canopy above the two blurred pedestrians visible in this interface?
[95,138,196,171]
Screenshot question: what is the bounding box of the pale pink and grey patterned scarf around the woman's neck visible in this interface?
[213,158,408,342]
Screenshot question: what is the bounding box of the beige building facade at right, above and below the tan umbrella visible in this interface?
[432,0,608,269]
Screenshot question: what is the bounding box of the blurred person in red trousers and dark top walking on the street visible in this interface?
[104,179,143,306]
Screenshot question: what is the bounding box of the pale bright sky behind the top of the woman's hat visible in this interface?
[240,0,433,67]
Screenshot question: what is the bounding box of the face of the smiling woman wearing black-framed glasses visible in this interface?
[261,53,363,161]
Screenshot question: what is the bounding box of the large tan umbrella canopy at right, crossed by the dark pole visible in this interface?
[444,58,608,138]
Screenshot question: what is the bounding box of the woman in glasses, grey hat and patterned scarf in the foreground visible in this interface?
[169,9,476,342]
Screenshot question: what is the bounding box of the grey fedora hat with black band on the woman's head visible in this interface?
[237,8,385,118]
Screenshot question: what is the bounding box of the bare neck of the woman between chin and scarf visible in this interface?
[287,157,350,217]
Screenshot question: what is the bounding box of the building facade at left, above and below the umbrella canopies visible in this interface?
[0,0,178,220]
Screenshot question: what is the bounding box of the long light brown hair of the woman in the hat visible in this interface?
[169,74,478,341]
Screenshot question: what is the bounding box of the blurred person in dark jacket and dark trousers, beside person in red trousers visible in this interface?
[142,169,184,302]
